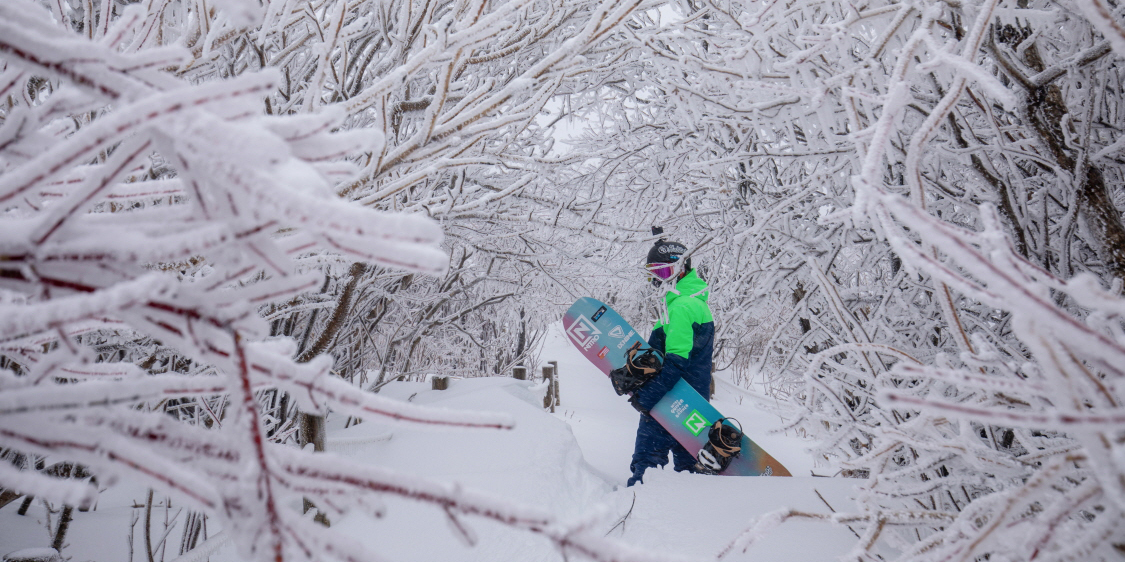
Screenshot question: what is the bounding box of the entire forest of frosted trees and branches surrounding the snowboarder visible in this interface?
[0,0,1125,562]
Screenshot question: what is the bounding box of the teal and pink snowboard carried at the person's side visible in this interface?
[563,297,792,477]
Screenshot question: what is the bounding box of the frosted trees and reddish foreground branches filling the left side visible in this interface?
[0,0,684,562]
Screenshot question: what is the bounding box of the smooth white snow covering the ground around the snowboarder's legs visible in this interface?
[0,321,856,562]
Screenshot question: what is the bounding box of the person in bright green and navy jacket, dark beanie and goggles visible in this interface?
[628,232,714,486]
